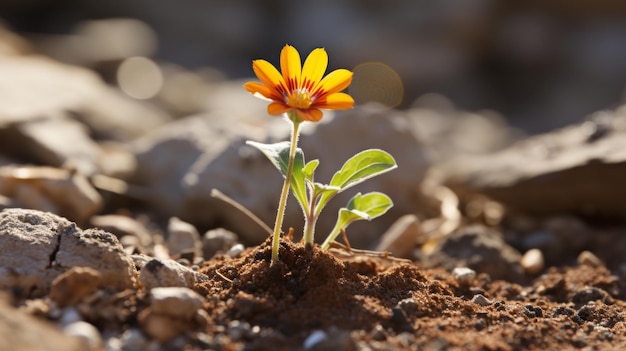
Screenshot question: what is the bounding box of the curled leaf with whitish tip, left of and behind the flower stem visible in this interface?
[246,140,310,210]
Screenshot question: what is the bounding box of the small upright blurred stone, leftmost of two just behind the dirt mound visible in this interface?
[166,217,202,261]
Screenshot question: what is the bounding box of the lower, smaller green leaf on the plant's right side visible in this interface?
[321,192,393,250]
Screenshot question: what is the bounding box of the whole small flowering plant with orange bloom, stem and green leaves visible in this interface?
[244,45,396,261]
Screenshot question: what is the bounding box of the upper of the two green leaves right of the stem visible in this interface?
[315,149,397,215]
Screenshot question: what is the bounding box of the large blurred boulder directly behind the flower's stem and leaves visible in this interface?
[129,104,428,245]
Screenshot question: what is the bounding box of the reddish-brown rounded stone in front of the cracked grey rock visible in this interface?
[49,267,102,307]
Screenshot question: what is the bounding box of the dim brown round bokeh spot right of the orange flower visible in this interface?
[349,62,404,109]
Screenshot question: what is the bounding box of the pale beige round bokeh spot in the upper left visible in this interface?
[117,57,163,99]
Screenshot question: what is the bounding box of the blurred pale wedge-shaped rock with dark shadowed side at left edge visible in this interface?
[0,117,101,176]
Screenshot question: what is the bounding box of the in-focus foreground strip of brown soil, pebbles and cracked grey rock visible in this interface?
[0,209,626,350]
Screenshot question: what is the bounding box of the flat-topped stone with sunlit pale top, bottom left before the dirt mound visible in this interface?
[150,287,204,320]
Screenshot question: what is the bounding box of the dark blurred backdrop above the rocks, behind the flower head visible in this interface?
[0,0,626,134]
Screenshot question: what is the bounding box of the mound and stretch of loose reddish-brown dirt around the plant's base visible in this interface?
[197,240,626,350]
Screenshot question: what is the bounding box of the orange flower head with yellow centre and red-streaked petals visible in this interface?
[244,45,354,122]
